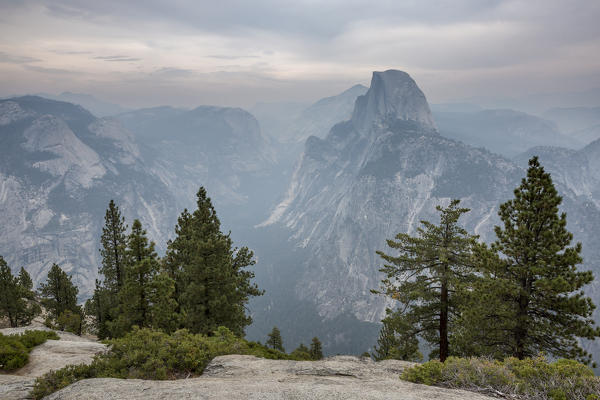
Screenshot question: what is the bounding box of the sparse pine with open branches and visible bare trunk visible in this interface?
[374,200,476,361]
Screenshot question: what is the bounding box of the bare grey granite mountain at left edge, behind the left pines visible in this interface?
[0,96,176,297]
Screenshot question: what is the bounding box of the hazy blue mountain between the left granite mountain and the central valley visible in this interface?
[116,106,285,226]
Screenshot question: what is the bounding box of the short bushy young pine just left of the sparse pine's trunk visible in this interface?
[373,309,423,361]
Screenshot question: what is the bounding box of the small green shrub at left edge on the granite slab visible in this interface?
[0,331,59,372]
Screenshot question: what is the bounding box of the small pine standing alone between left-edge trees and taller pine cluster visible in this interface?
[40,264,82,334]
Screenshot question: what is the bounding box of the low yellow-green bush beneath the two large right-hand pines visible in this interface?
[401,356,600,400]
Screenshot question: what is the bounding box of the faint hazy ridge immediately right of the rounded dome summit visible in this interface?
[433,110,568,157]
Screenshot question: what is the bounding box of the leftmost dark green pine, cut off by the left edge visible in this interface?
[0,256,41,328]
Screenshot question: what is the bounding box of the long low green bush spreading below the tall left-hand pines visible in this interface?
[32,327,302,399]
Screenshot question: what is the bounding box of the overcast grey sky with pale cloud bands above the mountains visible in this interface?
[0,0,600,107]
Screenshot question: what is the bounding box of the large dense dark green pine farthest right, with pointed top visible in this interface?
[473,157,600,362]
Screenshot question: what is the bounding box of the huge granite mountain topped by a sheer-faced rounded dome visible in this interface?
[251,70,600,364]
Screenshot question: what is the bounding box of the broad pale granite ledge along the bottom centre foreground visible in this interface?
[46,355,489,400]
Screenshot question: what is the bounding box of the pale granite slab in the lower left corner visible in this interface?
[0,324,106,400]
